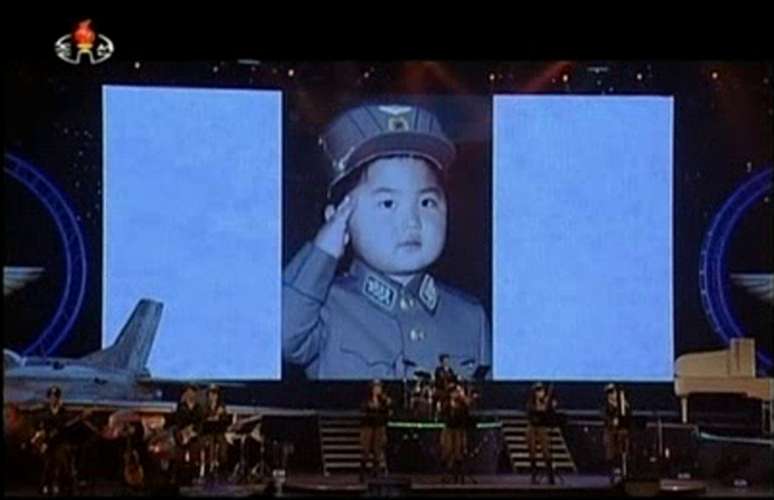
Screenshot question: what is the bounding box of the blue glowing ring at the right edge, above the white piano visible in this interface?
[699,168,774,369]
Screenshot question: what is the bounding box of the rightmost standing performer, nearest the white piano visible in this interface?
[602,384,631,481]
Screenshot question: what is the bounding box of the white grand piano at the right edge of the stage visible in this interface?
[675,338,774,433]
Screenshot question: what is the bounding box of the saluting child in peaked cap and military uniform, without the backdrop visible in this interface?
[282,105,491,379]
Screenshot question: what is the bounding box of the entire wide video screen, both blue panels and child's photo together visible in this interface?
[103,86,674,381]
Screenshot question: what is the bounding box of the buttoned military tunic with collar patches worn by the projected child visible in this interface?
[282,243,492,379]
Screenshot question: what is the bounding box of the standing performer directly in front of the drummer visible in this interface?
[441,383,471,483]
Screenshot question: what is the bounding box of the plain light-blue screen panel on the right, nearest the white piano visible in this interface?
[493,95,674,381]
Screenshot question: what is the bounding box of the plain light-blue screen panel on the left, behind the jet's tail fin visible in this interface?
[103,86,282,379]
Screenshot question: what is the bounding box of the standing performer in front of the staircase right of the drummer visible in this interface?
[527,382,558,484]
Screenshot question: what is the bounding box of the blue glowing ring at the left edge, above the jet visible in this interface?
[4,153,86,355]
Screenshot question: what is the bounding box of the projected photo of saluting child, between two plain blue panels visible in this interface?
[282,94,492,379]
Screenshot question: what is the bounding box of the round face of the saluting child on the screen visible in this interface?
[349,157,446,284]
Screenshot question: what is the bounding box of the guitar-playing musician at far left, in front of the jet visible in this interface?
[32,385,74,495]
